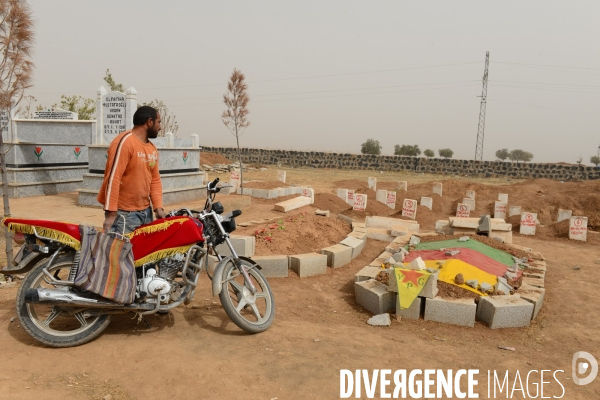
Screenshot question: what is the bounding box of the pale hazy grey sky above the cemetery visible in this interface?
[29,0,600,163]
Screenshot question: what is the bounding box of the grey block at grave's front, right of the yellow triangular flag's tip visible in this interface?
[425,297,477,328]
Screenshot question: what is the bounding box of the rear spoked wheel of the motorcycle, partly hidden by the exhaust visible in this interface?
[17,253,110,347]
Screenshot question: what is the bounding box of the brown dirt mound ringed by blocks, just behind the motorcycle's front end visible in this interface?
[236,211,350,256]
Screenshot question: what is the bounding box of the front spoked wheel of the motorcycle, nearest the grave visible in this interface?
[219,260,275,333]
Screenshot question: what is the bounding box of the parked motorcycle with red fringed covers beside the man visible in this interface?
[0,178,275,347]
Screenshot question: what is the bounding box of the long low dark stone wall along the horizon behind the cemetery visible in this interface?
[202,147,600,181]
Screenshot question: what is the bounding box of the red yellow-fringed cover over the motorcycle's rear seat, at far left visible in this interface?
[2,218,81,250]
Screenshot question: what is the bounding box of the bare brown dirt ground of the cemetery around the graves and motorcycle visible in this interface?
[0,167,600,399]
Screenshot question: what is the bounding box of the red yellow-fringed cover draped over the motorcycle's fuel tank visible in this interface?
[127,217,204,267]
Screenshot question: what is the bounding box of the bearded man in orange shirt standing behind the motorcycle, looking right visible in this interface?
[97,106,165,233]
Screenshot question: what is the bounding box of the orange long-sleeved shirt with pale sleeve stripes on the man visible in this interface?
[97,131,163,211]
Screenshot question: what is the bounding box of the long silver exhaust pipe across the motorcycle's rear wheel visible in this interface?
[25,289,155,310]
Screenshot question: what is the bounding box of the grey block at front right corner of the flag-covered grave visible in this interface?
[477,295,534,329]
